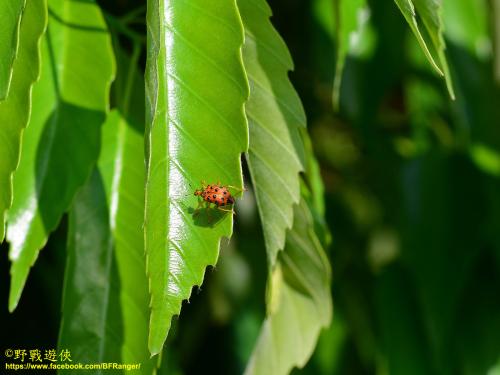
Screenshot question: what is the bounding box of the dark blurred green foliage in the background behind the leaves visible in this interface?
[0,0,500,375]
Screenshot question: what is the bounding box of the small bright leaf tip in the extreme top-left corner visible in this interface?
[0,0,25,100]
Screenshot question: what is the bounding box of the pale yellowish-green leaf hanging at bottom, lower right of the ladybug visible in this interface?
[245,199,332,375]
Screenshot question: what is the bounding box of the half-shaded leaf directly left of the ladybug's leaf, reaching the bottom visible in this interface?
[59,48,155,374]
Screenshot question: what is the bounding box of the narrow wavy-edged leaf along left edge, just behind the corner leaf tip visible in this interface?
[0,1,47,242]
